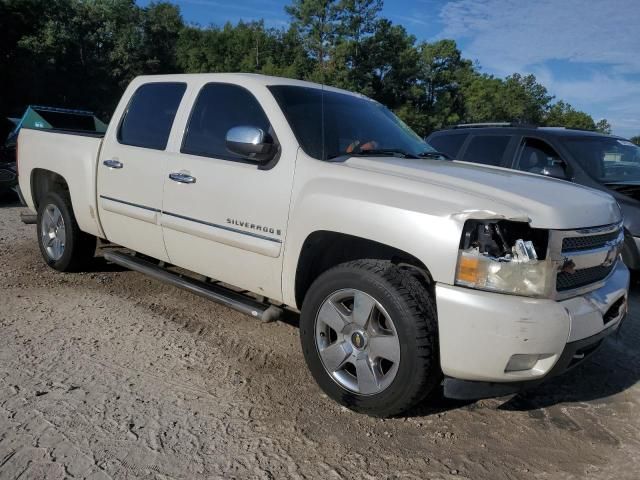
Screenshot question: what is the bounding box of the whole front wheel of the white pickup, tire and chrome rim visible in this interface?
[300,260,442,417]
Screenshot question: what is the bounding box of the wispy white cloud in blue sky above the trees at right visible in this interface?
[440,0,640,136]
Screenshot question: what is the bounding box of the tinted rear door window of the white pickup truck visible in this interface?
[118,83,187,150]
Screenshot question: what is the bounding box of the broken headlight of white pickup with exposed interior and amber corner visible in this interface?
[456,220,553,297]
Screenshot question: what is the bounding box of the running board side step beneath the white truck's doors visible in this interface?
[103,251,282,322]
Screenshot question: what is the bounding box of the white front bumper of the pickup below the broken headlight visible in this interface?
[436,262,629,383]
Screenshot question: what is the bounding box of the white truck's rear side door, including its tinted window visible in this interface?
[98,82,186,261]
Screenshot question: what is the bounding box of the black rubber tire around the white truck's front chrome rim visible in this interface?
[300,260,442,417]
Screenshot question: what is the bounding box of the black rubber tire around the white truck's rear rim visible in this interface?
[37,192,96,272]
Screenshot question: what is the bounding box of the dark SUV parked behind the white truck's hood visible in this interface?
[427,123,640,270]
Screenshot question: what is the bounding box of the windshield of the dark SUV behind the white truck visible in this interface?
[563,136,640,183]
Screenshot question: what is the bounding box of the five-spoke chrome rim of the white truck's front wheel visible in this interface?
[315,289,400,395]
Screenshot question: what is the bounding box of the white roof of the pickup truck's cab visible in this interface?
[134,73,364,97]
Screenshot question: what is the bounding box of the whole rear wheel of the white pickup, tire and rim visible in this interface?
[37,192,96,272]
